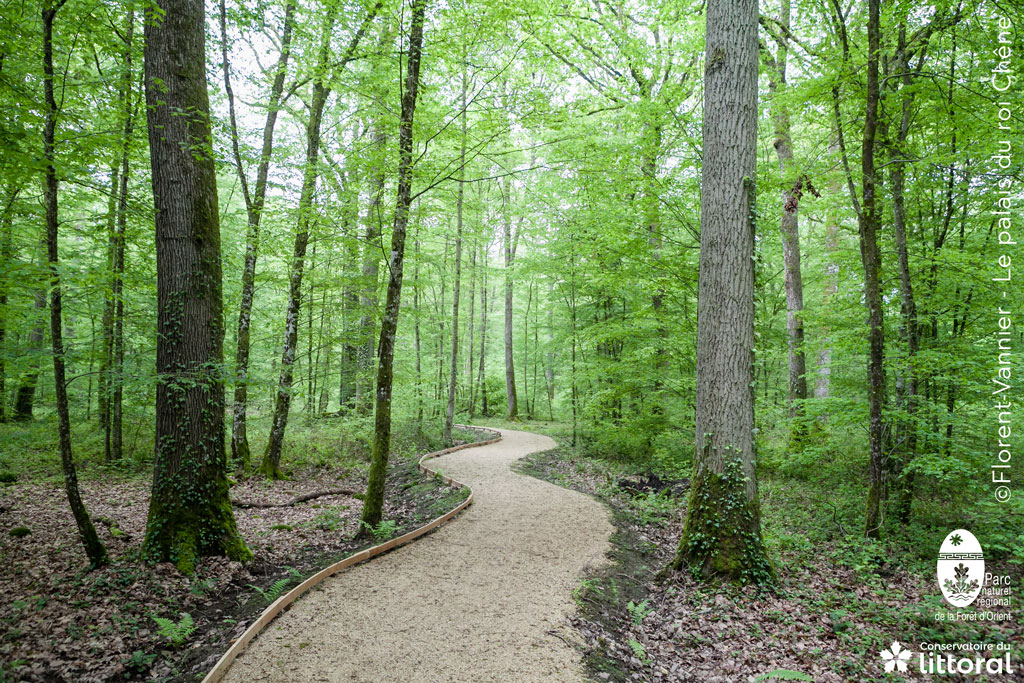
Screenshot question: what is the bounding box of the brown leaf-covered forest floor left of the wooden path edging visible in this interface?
[0,421,483,683]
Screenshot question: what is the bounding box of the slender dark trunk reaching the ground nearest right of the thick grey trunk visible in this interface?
[858,0,886,539]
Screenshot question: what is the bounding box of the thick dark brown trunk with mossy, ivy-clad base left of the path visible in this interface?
[142,0,252,573]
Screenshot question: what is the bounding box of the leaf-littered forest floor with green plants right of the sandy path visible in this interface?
[512,440,1024,683]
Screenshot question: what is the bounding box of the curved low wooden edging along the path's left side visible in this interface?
[203,425,502,683]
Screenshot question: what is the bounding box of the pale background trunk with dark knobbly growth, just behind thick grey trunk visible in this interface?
[769,0,807,443]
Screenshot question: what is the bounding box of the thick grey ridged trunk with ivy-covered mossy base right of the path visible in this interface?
[674,0,773,584]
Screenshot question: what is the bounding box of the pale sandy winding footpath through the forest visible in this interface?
[224,430,612,683]
